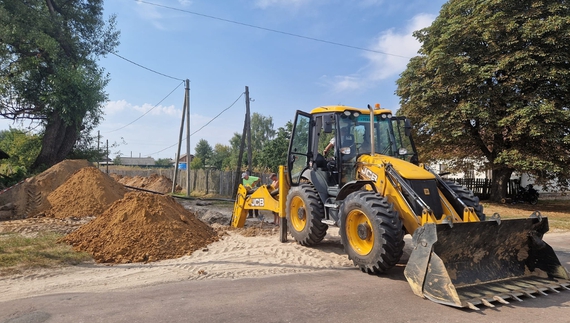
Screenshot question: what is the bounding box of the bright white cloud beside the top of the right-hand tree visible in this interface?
[329,14,435,92]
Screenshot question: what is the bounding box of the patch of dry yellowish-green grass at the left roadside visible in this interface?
[0,233,92,276]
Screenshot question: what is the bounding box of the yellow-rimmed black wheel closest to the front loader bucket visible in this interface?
[340,191,404,274]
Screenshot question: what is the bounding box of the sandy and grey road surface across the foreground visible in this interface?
[0,233,570,323]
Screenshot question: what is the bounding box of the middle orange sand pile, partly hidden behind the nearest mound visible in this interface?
[46,167,127,219]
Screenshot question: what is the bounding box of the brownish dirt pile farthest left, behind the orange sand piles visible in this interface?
[0,159,92,219]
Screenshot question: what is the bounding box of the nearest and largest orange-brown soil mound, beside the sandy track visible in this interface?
[60,192,218,263]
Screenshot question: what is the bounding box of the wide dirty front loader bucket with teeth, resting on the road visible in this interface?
[404,216,570,309]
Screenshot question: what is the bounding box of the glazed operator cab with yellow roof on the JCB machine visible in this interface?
[288,106,417,196]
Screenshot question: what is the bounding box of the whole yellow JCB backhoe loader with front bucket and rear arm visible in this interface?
[232,105,570,309]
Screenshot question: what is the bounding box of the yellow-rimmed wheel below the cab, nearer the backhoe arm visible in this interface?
[286,184,328,246]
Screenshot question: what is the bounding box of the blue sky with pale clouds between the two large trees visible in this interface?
[5,0,445,159]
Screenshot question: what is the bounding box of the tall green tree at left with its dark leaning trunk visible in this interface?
[0,0,119,168]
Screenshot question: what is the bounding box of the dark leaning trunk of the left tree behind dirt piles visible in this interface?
[32,112,79,170]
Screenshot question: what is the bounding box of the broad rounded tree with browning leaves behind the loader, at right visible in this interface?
[397,0,570,200]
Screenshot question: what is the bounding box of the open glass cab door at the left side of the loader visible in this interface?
[287,110,314,186]
